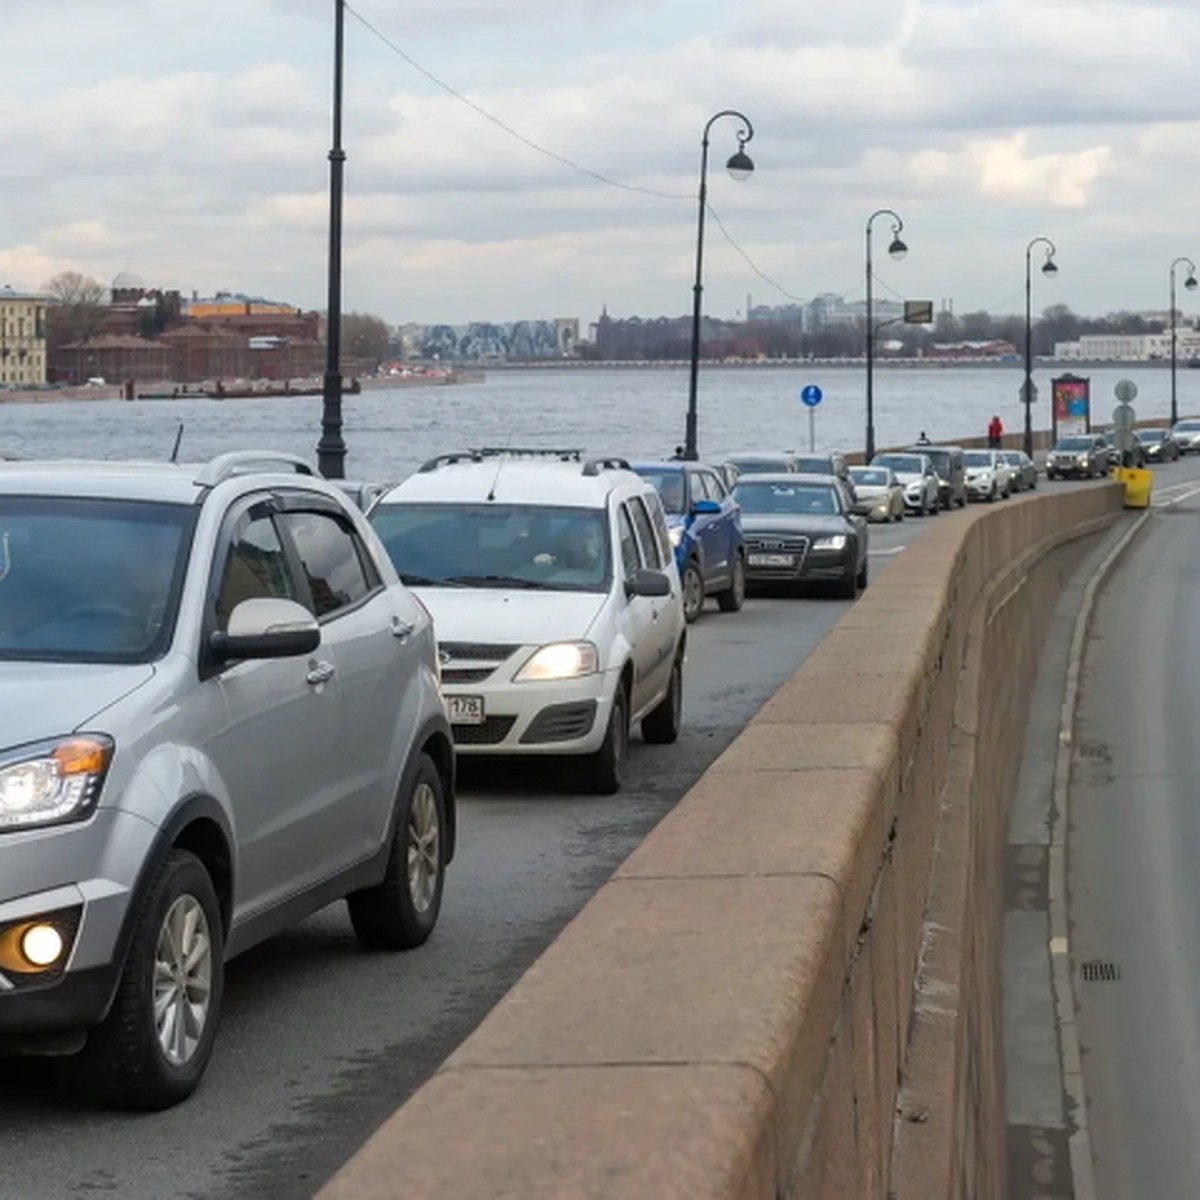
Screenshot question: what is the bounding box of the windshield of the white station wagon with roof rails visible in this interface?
[371,504,612,592]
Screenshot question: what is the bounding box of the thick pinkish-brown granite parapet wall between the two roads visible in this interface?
[320,484,1122,1200]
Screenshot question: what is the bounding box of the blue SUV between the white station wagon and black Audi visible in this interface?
[632,462,746,623]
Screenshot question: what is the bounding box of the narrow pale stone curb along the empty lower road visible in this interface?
[1050,506,1152,1200]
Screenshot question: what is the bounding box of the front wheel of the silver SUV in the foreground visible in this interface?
[76,850,224,1112]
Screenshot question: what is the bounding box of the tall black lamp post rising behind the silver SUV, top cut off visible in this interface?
[317,0,346,479]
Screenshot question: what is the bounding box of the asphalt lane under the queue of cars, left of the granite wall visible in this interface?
[0,530,912,1200]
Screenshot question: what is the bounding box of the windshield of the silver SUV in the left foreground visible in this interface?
[0,496,196,662]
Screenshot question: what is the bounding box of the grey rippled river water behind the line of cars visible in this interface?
[0,364,1200,480]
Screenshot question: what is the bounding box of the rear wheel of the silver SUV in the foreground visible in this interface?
[346,752,446,950]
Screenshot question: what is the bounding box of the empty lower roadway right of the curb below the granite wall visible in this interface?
[1068,482,1200,1200]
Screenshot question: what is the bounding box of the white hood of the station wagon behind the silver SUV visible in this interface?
[410,588,608,646]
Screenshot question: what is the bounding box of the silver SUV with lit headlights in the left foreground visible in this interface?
[0,452,455,1109]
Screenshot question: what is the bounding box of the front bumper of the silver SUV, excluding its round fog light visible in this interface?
[0,809,156,1049]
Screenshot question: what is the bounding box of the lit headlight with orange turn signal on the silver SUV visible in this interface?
[0,734,113,833]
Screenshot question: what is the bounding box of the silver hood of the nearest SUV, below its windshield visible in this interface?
[0,661,154,749]
